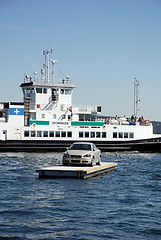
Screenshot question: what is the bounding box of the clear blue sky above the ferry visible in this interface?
[0,0,161,121]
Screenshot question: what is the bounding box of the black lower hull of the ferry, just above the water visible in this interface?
[0,138,161,152]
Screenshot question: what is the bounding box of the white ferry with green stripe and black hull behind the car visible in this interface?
[0,50,161,152]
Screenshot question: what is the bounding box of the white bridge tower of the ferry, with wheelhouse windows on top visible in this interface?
[21,79,75,124]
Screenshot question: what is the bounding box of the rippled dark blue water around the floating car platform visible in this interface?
[0,153,161,240]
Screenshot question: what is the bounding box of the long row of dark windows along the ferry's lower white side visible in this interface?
[24,131,134,138]
